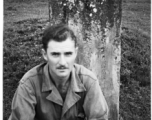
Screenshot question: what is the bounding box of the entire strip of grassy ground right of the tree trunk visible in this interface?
[120,0,151,120]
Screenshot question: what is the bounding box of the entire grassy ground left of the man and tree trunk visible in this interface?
[3,2,48,120]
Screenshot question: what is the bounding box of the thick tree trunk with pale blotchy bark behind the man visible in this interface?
[50,0,122,120]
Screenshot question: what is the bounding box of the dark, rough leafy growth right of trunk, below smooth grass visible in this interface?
[120,30,151,120]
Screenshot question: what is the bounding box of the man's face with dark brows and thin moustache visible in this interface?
[43,38,78,79]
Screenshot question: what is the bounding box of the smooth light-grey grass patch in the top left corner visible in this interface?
[4,1,48,29]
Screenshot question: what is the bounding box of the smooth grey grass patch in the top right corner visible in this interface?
[122,0,151,36]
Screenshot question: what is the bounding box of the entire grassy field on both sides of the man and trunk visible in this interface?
[3,0,151,120]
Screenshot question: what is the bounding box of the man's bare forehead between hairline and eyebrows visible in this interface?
[47,38,75,52]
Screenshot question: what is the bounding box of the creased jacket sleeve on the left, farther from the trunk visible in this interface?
[9,80,36,120]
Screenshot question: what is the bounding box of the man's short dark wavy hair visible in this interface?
[42,24,77,50]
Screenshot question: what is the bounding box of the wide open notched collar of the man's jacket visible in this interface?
[42,64,86,113]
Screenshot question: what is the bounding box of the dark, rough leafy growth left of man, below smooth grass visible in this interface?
[3,19,45,119]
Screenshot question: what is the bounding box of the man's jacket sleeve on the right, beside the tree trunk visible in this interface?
[83,80,108,120]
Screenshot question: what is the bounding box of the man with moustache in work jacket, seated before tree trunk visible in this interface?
[9,24,108,120]
